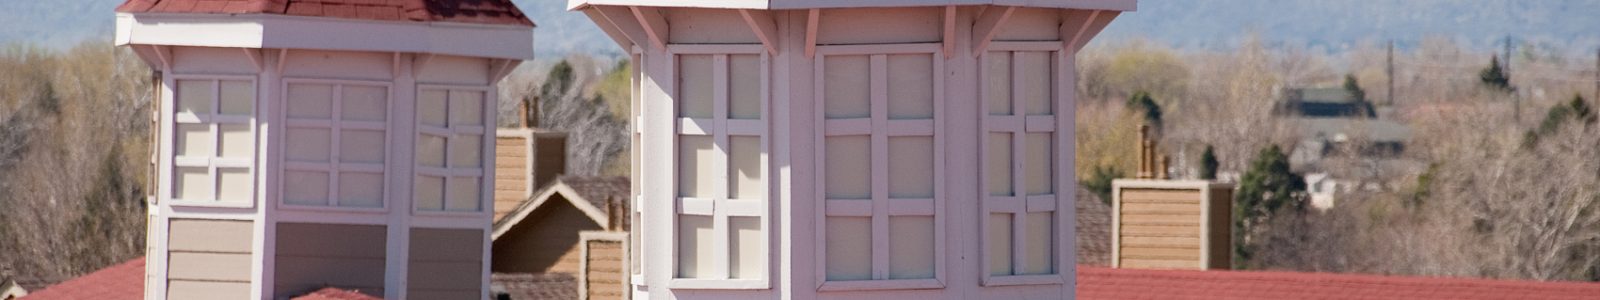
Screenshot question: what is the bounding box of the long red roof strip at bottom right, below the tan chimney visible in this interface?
[1077,265,1600,300]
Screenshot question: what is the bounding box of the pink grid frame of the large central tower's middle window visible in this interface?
[811,43,949,292]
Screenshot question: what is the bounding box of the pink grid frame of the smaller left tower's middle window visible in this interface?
[274,77,395,214]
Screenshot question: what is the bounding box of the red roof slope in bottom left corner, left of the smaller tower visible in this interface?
[22,257,144,300]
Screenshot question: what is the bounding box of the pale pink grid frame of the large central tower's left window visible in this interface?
[668,45,774,290]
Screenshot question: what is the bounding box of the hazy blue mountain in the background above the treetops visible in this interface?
[0,0,1600,57]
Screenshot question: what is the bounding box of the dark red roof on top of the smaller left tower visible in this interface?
[117,0,533,26]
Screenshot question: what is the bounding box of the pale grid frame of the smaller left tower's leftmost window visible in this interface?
[166,73,262,207]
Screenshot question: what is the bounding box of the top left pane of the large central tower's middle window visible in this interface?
[822,56,872,118]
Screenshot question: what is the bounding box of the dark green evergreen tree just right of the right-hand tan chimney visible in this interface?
[1234,145,1306,268]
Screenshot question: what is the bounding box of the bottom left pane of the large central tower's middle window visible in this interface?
[824,217,872,281]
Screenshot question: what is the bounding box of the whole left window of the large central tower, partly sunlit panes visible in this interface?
[670,45,770,289]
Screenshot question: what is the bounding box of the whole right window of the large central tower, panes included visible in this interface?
[979,41,1070,286]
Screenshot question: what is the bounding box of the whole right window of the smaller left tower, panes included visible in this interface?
[413,86,493,212]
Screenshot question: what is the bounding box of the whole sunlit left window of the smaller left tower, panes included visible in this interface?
[170,77,256,206]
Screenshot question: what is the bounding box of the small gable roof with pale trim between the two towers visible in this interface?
[493,176,632,239]
